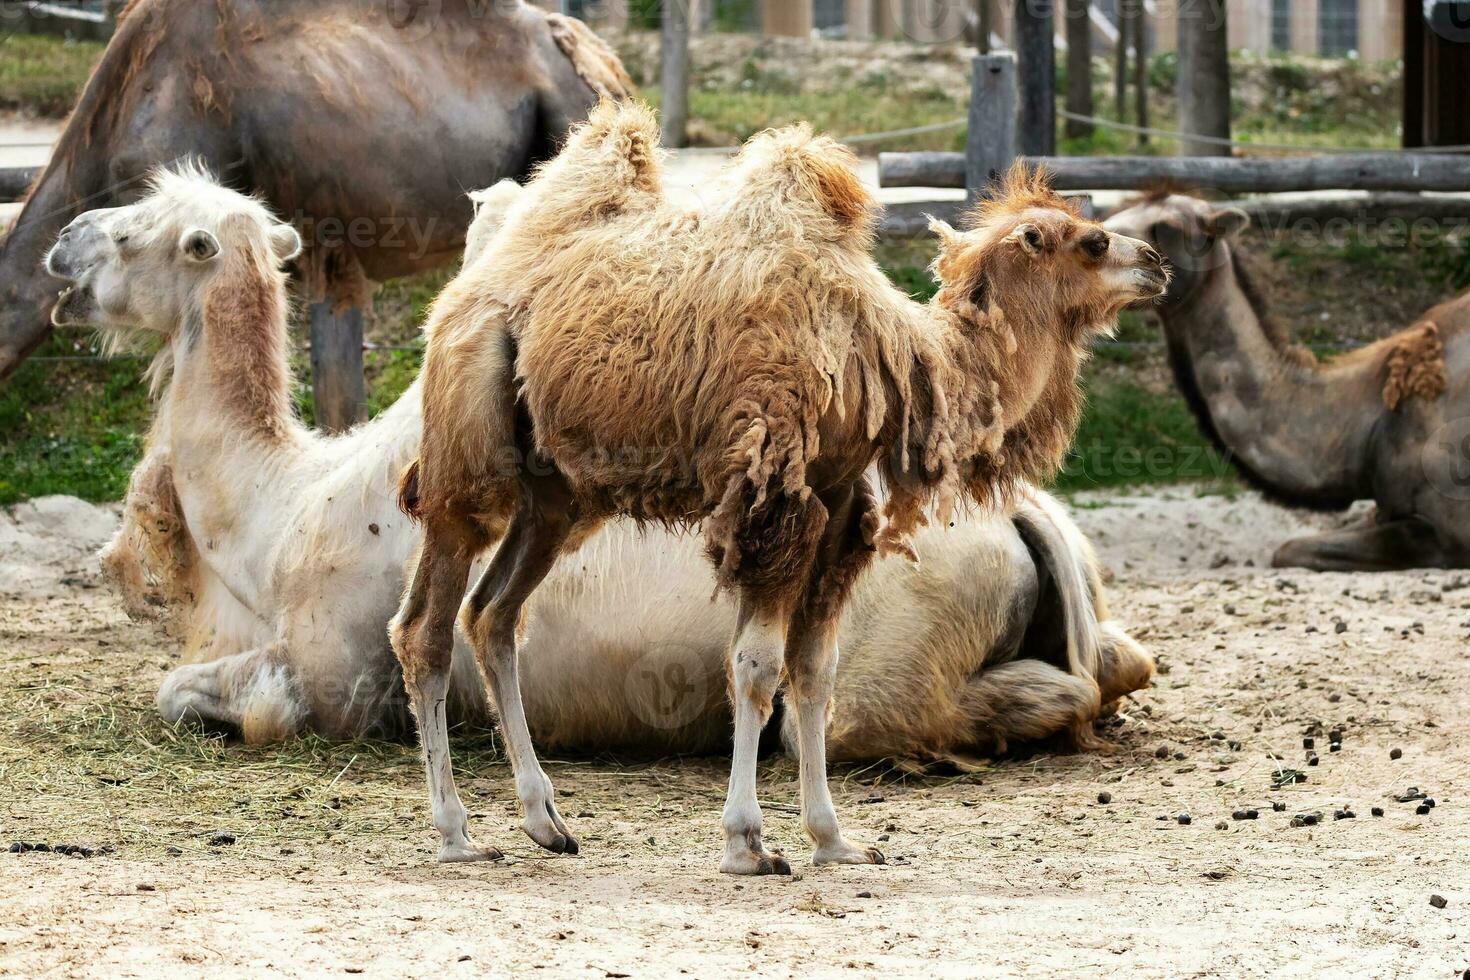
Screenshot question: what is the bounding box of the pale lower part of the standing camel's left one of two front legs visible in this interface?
[720,599,791,874]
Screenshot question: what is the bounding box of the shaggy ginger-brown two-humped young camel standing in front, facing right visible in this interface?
[391,103,1166,874]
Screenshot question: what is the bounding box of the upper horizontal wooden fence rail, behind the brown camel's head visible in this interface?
[878,153,1470,194]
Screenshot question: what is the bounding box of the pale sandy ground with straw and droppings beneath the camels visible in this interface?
[0,491,1470,977]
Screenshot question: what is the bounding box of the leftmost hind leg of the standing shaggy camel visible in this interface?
[388,522,490,861]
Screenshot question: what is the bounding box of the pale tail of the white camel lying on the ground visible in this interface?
[1014,494,1103,696]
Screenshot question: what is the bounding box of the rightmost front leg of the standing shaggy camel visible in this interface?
[786,483,883,864]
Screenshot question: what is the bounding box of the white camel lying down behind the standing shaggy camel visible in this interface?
[47,170,1152,761]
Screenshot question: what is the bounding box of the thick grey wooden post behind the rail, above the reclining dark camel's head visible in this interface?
[1179,0,1230,157]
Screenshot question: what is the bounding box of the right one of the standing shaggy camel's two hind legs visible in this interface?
[460,475,578,854]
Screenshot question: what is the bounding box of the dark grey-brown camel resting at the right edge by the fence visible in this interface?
[1107,194,1470,572]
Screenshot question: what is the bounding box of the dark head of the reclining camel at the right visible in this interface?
[1104,192,1251,310]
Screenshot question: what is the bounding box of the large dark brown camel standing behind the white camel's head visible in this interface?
[0,0,632,378]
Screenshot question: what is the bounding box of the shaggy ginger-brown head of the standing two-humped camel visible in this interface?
[932,163,1169,350]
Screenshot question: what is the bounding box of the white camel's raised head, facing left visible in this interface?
[46,165,301,336]
